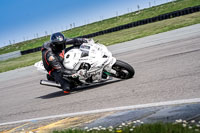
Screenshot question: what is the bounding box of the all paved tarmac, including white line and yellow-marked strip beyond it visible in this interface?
[0,24,200,132]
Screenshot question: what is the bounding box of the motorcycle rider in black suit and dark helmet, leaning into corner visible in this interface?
[41,32,87,93]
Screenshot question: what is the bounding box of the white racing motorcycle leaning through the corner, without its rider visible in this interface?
[34,39,135,89]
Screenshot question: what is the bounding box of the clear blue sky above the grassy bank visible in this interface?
[0,0,170,47]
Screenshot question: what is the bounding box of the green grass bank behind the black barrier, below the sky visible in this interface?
[0,0,200,54]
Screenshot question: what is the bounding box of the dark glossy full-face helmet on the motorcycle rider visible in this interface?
[50,32,66,52]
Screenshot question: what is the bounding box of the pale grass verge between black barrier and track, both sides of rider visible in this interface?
[0,12,200,72]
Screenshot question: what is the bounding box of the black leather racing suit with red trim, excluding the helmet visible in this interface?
[41,38,85,90]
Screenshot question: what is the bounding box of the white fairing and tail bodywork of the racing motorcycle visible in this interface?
[35,39,116,83]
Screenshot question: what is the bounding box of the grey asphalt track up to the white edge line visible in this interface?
[0,24,200,123]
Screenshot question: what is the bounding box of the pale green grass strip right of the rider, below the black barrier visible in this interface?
[94,12,200,45]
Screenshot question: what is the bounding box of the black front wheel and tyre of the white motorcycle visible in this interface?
[112,60,135,79]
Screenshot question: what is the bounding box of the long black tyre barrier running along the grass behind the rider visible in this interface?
[21,5,200,55]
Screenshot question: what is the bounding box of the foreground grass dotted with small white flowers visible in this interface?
[53,123,200,133]
